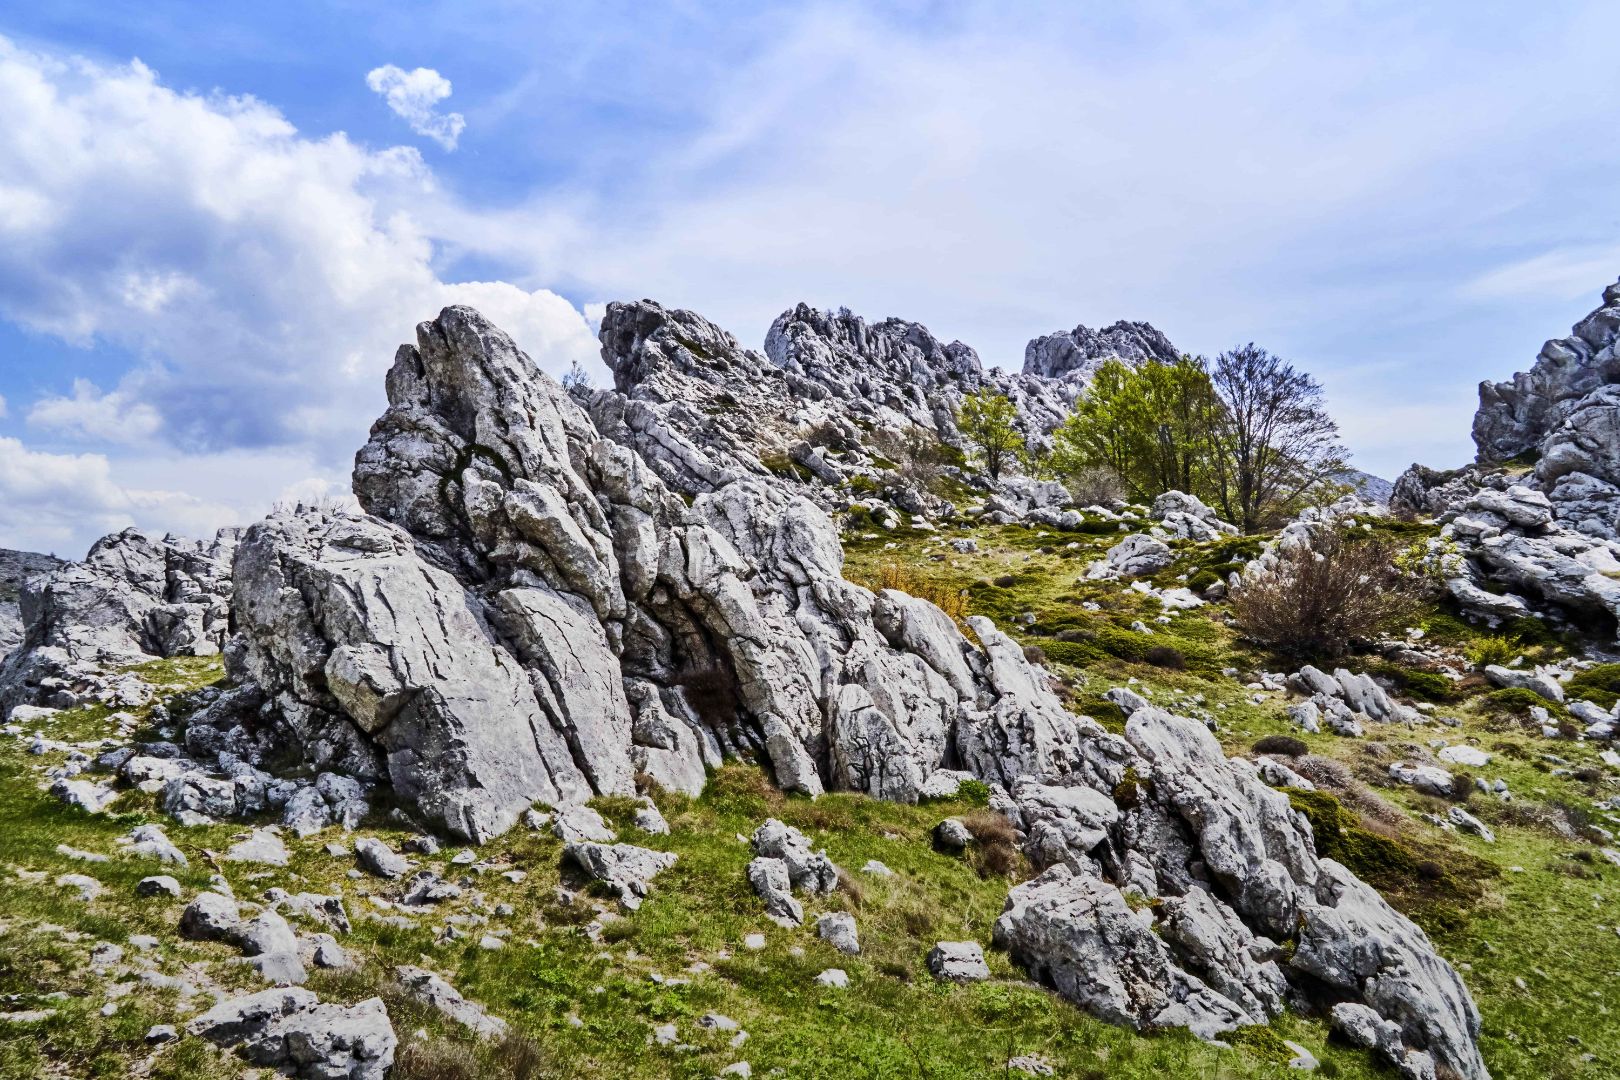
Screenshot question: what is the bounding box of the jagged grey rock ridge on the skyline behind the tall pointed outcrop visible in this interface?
[580,300,1175,517]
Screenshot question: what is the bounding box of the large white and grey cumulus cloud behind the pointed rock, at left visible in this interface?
[0,39,598,546]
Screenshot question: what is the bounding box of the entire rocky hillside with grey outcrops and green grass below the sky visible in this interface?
[9,291,1620,1080]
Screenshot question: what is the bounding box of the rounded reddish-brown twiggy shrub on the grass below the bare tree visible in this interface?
[1231,531,1422,657]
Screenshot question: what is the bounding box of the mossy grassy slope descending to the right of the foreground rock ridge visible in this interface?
[846,523,1620,1077]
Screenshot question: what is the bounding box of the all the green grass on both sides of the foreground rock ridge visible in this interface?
[0,511,1620,1080]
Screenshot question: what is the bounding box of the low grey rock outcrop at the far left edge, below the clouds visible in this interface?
[0,529,237,714]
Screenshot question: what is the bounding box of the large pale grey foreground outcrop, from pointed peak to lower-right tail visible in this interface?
[215,306,1486,1078]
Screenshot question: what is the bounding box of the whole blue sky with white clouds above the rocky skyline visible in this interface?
[0,0,1620,555]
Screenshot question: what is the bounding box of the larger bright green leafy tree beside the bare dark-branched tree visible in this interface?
[1053,356,1221,502]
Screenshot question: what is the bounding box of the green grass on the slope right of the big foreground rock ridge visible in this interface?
[846,511,1620,1078]
